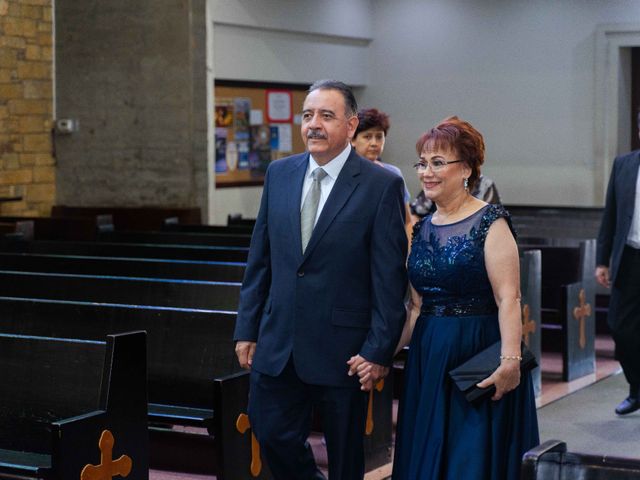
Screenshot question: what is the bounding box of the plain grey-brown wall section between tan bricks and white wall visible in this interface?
[55,0,208,218]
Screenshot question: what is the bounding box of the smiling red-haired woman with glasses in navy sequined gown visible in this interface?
[393,117,539,480]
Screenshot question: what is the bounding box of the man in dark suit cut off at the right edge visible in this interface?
[595,115,640,415]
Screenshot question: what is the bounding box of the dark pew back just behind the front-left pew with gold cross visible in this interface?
[0,298,241,409]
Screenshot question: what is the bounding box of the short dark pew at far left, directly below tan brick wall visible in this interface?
[0,215,113,241]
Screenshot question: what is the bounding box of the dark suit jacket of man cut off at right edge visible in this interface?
[596,150,640,283]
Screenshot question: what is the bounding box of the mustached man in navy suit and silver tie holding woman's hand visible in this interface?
[234,80,407,480]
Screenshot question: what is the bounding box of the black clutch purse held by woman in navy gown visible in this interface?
[449,341,538,405]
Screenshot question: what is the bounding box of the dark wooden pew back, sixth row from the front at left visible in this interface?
[100,230,251,247]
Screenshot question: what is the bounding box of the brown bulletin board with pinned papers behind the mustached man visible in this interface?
[214,81,308,188]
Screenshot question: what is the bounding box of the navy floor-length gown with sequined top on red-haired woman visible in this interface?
[393,205,539,480]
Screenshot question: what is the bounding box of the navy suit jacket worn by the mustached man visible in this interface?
[234,150,407,386]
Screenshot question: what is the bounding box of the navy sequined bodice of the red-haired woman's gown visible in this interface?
[408,205,509,315]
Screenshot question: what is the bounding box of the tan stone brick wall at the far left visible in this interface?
[0,0,56,215]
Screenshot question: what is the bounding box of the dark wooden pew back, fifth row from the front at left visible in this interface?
[0,239,249,263]
